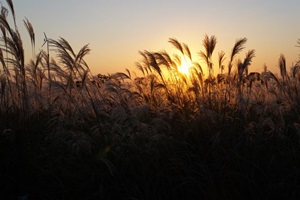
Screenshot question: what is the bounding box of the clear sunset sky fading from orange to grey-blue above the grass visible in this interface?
[14,0,300,74]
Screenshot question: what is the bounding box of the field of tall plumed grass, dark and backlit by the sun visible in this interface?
[0,0,300,200]
